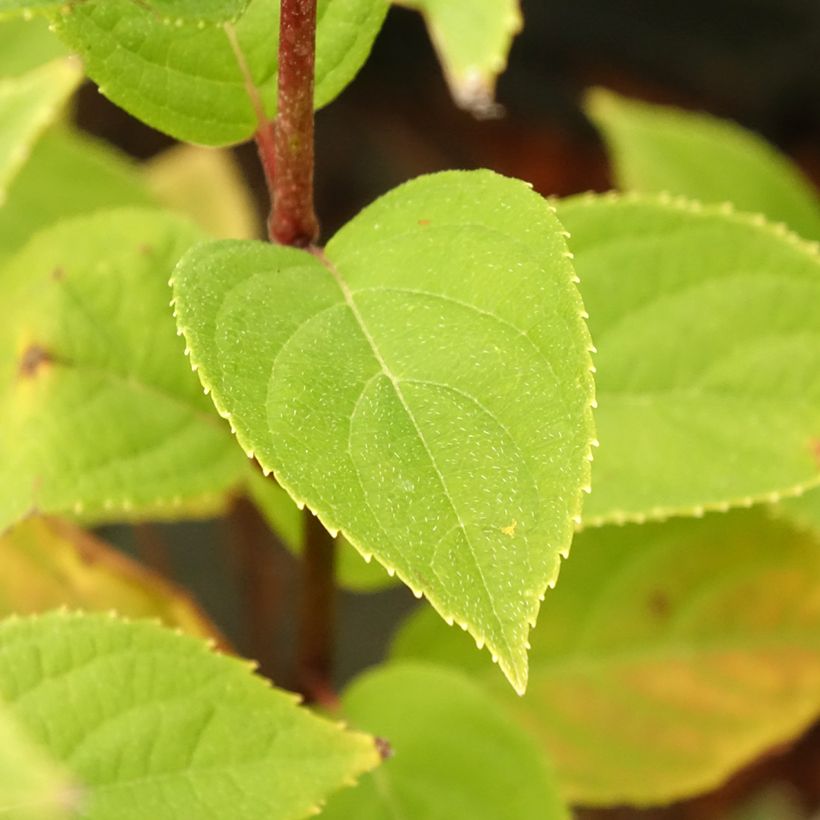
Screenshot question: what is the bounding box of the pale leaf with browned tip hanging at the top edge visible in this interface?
[395,0,523,117]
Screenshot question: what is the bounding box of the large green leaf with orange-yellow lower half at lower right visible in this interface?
[395,510,820,804]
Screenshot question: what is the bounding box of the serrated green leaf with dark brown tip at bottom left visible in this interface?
[0,613,379,820]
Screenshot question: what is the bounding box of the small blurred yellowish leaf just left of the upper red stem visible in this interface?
[145,145,262,239]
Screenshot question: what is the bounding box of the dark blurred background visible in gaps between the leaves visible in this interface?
[79,0,820,820]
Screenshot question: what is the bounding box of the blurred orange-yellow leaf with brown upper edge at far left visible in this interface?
[0,518,225,645]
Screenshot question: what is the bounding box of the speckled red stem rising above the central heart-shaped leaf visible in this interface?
[270,0,319,247]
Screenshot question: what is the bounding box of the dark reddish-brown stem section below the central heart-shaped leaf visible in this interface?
[297,510,337,708]
